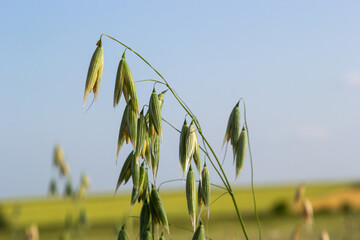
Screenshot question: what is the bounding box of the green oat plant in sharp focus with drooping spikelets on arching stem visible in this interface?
[83,34,261,239]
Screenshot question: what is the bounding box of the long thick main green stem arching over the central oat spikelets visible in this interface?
[100,34,249,240]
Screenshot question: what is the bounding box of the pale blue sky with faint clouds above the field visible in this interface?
[0,0,360,199]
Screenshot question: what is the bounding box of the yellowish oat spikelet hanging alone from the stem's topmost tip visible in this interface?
[83,39,104,106]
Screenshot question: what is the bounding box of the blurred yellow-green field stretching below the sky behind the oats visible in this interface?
[0,183,360,240]
